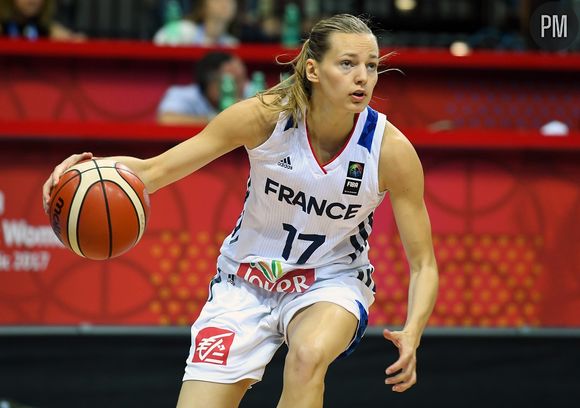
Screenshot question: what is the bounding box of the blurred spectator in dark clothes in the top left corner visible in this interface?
[0,0,85,40]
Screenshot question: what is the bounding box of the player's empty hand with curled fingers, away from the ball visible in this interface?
[383,329,418,392]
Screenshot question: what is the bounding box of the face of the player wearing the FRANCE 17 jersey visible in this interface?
[307,33,379,112]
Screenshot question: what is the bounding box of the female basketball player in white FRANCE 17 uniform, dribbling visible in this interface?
[44,14,438,408]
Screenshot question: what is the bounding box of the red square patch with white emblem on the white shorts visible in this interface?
[191,327,236,365]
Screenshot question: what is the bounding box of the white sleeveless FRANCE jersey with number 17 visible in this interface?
[218,107,386,292]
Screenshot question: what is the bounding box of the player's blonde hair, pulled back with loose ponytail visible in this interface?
[257,14,391,125]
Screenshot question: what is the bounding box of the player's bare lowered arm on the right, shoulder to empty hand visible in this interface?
[379,123,438,391]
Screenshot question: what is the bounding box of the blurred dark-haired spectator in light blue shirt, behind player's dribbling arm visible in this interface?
[157,51,252,125]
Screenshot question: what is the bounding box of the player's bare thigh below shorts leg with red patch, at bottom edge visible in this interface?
[177,379,254,408]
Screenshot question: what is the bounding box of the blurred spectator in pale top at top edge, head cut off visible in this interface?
[153,0,239,47]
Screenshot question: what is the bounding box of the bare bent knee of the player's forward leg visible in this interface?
[286,342,330,382]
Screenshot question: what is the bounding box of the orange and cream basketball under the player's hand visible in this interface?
[48,159,150,260]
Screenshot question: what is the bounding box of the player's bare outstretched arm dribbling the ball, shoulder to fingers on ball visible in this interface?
[43,98,276,210]
